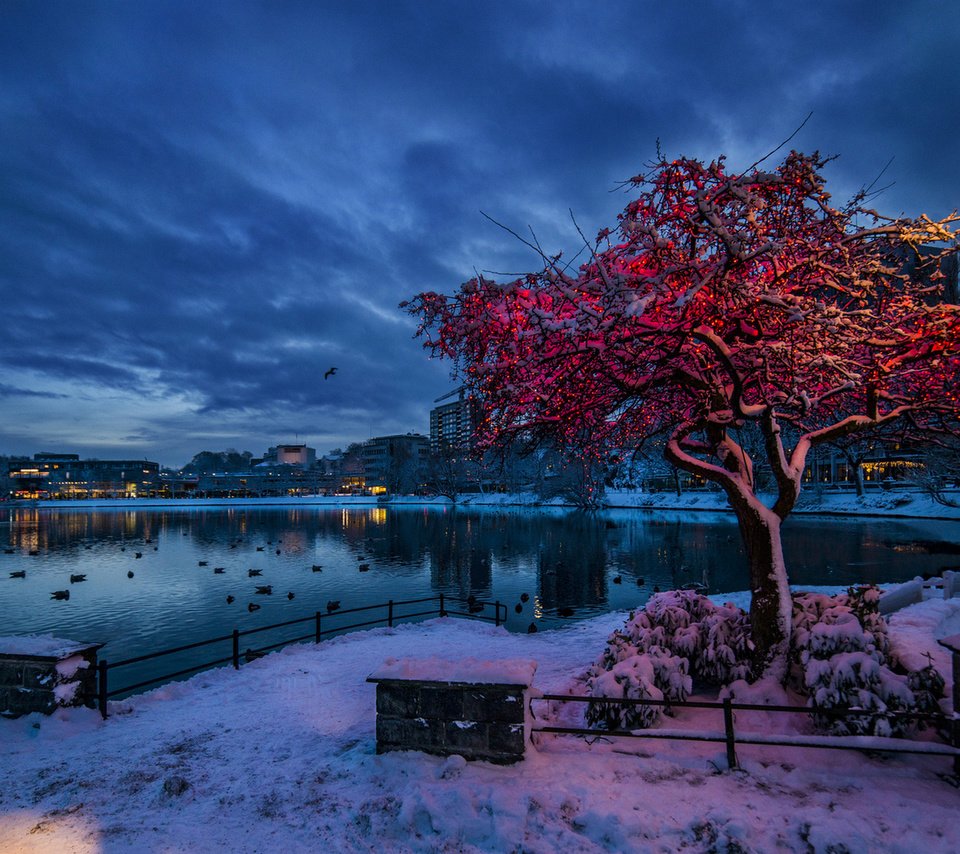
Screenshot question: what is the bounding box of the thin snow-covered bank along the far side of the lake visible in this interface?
[7,490,960,522]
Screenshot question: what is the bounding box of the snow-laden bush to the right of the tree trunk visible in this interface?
[792,587,943,736]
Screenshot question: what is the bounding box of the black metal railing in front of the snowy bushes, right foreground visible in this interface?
[530,694,960,776]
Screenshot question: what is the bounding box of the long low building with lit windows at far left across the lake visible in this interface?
[8,453,160,498]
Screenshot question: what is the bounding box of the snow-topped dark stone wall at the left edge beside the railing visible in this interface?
[0,638,102,718]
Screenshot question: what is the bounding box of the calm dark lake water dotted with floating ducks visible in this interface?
[0,507,960,696]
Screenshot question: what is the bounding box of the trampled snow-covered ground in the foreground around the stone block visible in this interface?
[0,596,960,854]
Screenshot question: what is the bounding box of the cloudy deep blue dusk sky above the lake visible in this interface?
[0,0,960,467]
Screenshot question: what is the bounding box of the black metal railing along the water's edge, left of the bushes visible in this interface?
[97,593,507,718]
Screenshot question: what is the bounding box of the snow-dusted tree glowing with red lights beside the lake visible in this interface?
[406,152,960,678]
